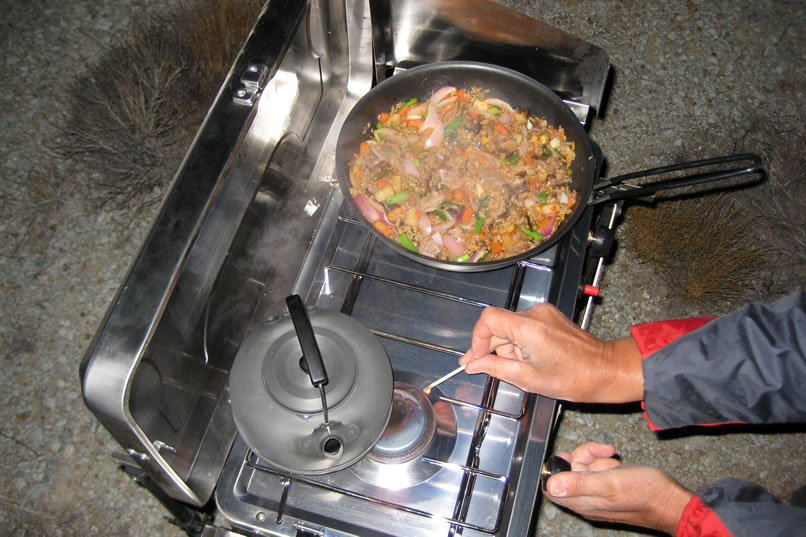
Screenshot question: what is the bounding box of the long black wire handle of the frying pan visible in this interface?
[588,153,764,205]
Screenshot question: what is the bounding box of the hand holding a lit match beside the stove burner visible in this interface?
[459,304,644,403]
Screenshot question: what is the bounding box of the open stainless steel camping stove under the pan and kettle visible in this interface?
[81,0,608,537]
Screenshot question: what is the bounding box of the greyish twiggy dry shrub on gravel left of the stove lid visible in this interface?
[57,18,197,208]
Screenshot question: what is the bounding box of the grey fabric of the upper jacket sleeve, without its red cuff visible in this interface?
[643,291,806,429]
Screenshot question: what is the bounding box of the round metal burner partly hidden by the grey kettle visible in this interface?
[369,382,436,463]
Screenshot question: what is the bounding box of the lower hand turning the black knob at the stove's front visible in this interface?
[546,442,692,535]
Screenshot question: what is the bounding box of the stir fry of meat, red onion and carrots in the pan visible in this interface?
[349,86,577,263]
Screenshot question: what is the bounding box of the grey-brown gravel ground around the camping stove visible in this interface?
[0,0,806,537]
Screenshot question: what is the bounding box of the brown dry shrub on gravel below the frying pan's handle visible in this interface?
[625,193,767,304]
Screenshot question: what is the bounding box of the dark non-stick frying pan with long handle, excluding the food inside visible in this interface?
[336,61,761,272]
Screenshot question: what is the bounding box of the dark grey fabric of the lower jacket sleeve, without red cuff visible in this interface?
[695,479,806,537]
